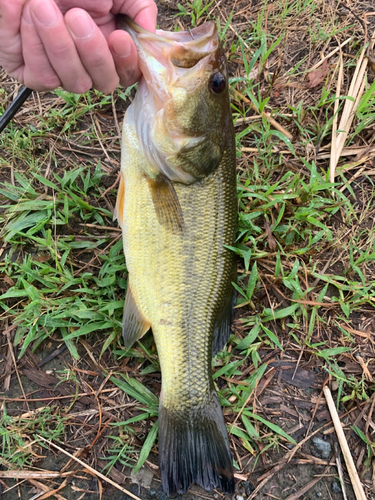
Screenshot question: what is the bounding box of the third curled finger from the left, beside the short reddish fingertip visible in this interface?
[65,9,119,93]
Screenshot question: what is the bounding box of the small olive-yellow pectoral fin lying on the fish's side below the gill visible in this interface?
[148,174,185,233]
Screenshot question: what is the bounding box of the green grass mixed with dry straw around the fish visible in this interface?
[0,0,375,496]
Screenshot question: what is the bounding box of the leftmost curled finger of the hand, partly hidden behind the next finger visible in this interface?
[21,5,61,90]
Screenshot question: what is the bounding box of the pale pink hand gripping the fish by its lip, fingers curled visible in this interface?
[0,0,157,94]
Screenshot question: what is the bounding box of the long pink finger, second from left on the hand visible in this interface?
[30,0,92,94]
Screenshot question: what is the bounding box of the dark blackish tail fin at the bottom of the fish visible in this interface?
[159,392,234,495]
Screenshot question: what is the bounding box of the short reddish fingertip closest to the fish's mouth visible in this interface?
[108,30,141,87]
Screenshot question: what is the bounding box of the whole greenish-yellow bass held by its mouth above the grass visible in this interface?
[115,16,238,495]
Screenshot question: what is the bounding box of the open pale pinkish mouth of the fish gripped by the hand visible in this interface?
[117,14,219,69]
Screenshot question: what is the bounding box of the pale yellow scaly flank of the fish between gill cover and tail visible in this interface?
[123,121,236,407]
